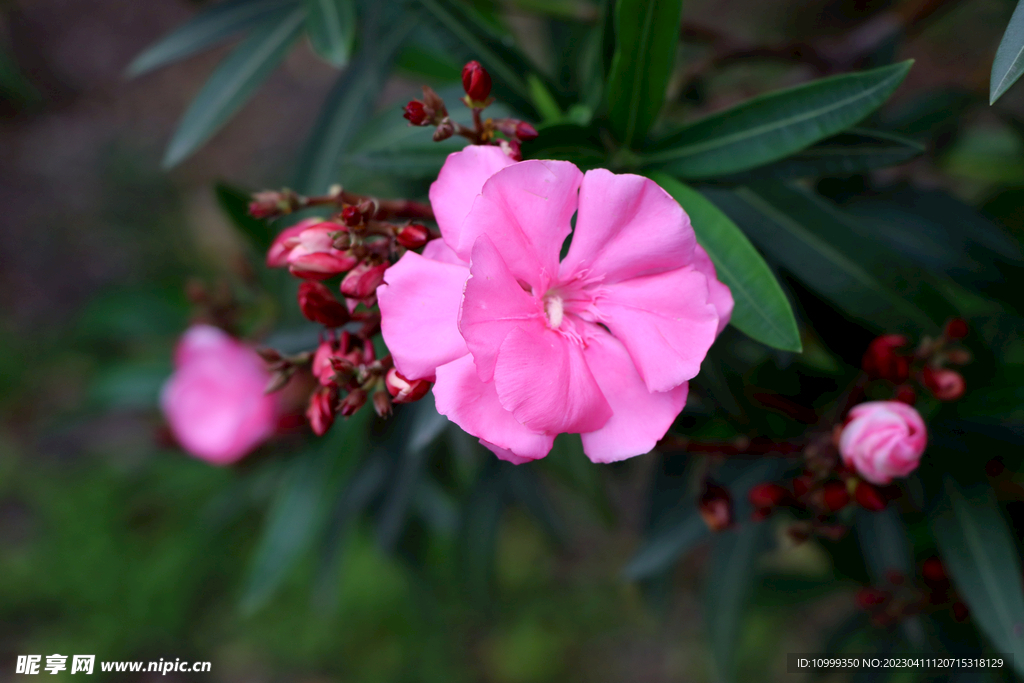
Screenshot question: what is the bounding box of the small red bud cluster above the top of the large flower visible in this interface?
[402,61,537,161]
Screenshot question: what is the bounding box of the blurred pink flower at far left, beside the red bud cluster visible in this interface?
[161,325,278,465]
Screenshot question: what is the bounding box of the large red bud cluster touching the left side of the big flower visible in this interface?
[250,186,436,435]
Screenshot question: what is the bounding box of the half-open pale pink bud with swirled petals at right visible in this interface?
[839,400,928,484]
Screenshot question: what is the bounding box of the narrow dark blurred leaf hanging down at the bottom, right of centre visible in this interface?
[705,522,770,682]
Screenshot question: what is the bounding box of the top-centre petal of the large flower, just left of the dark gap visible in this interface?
[449,161,583,286]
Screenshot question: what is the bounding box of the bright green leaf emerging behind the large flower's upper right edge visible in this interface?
[650,173,803,352]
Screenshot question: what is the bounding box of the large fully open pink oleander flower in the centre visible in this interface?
[377,146,732,464]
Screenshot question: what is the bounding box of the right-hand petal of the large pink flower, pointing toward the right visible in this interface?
[595,267,718,391]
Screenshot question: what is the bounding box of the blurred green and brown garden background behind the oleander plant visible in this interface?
[0,0,1024,683]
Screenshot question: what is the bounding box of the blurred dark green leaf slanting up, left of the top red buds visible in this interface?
[295,20,412,195]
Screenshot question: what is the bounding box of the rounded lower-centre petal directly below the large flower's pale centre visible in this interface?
[495,322,611,434]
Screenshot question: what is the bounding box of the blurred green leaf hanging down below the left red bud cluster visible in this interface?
[242,410,372,613]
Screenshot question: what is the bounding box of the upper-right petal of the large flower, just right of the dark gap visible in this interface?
[561,169,696,283]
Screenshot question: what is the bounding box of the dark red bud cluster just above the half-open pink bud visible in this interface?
[861,317,971,405]
